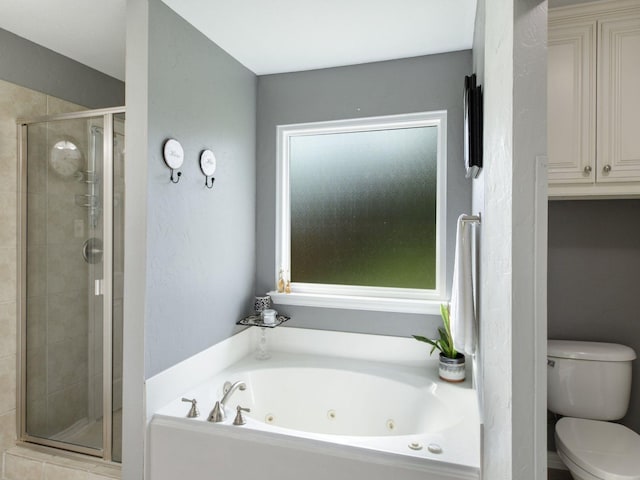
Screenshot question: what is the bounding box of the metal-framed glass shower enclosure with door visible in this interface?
[18,108,125,462]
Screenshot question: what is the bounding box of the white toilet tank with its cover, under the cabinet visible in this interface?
[547,340,636,420]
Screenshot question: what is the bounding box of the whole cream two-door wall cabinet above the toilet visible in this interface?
[547,0,640,197]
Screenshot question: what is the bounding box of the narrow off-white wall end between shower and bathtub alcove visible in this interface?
[122,0,149,480]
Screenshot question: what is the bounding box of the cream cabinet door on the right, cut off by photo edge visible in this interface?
[596,13,640,182]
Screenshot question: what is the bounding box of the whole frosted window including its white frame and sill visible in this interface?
[272,111,447,313]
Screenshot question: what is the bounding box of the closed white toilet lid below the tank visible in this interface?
[556,417,640,480]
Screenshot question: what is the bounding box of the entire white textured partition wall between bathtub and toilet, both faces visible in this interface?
[473,0,547,480]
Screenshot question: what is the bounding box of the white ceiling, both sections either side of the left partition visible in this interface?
[0,0,476,80]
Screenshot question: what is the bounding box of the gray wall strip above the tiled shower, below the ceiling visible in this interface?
[0,28,124,108]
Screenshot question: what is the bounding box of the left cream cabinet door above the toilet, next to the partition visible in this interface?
[547,21,596,184]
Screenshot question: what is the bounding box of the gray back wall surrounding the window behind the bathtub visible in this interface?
[256,51,471,336]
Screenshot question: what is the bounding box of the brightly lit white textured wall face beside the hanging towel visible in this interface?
[474,0,513,472]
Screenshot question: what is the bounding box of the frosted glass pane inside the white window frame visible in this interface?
[289,126,438,290]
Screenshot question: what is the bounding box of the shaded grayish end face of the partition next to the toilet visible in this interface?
[511,0,547,479]
